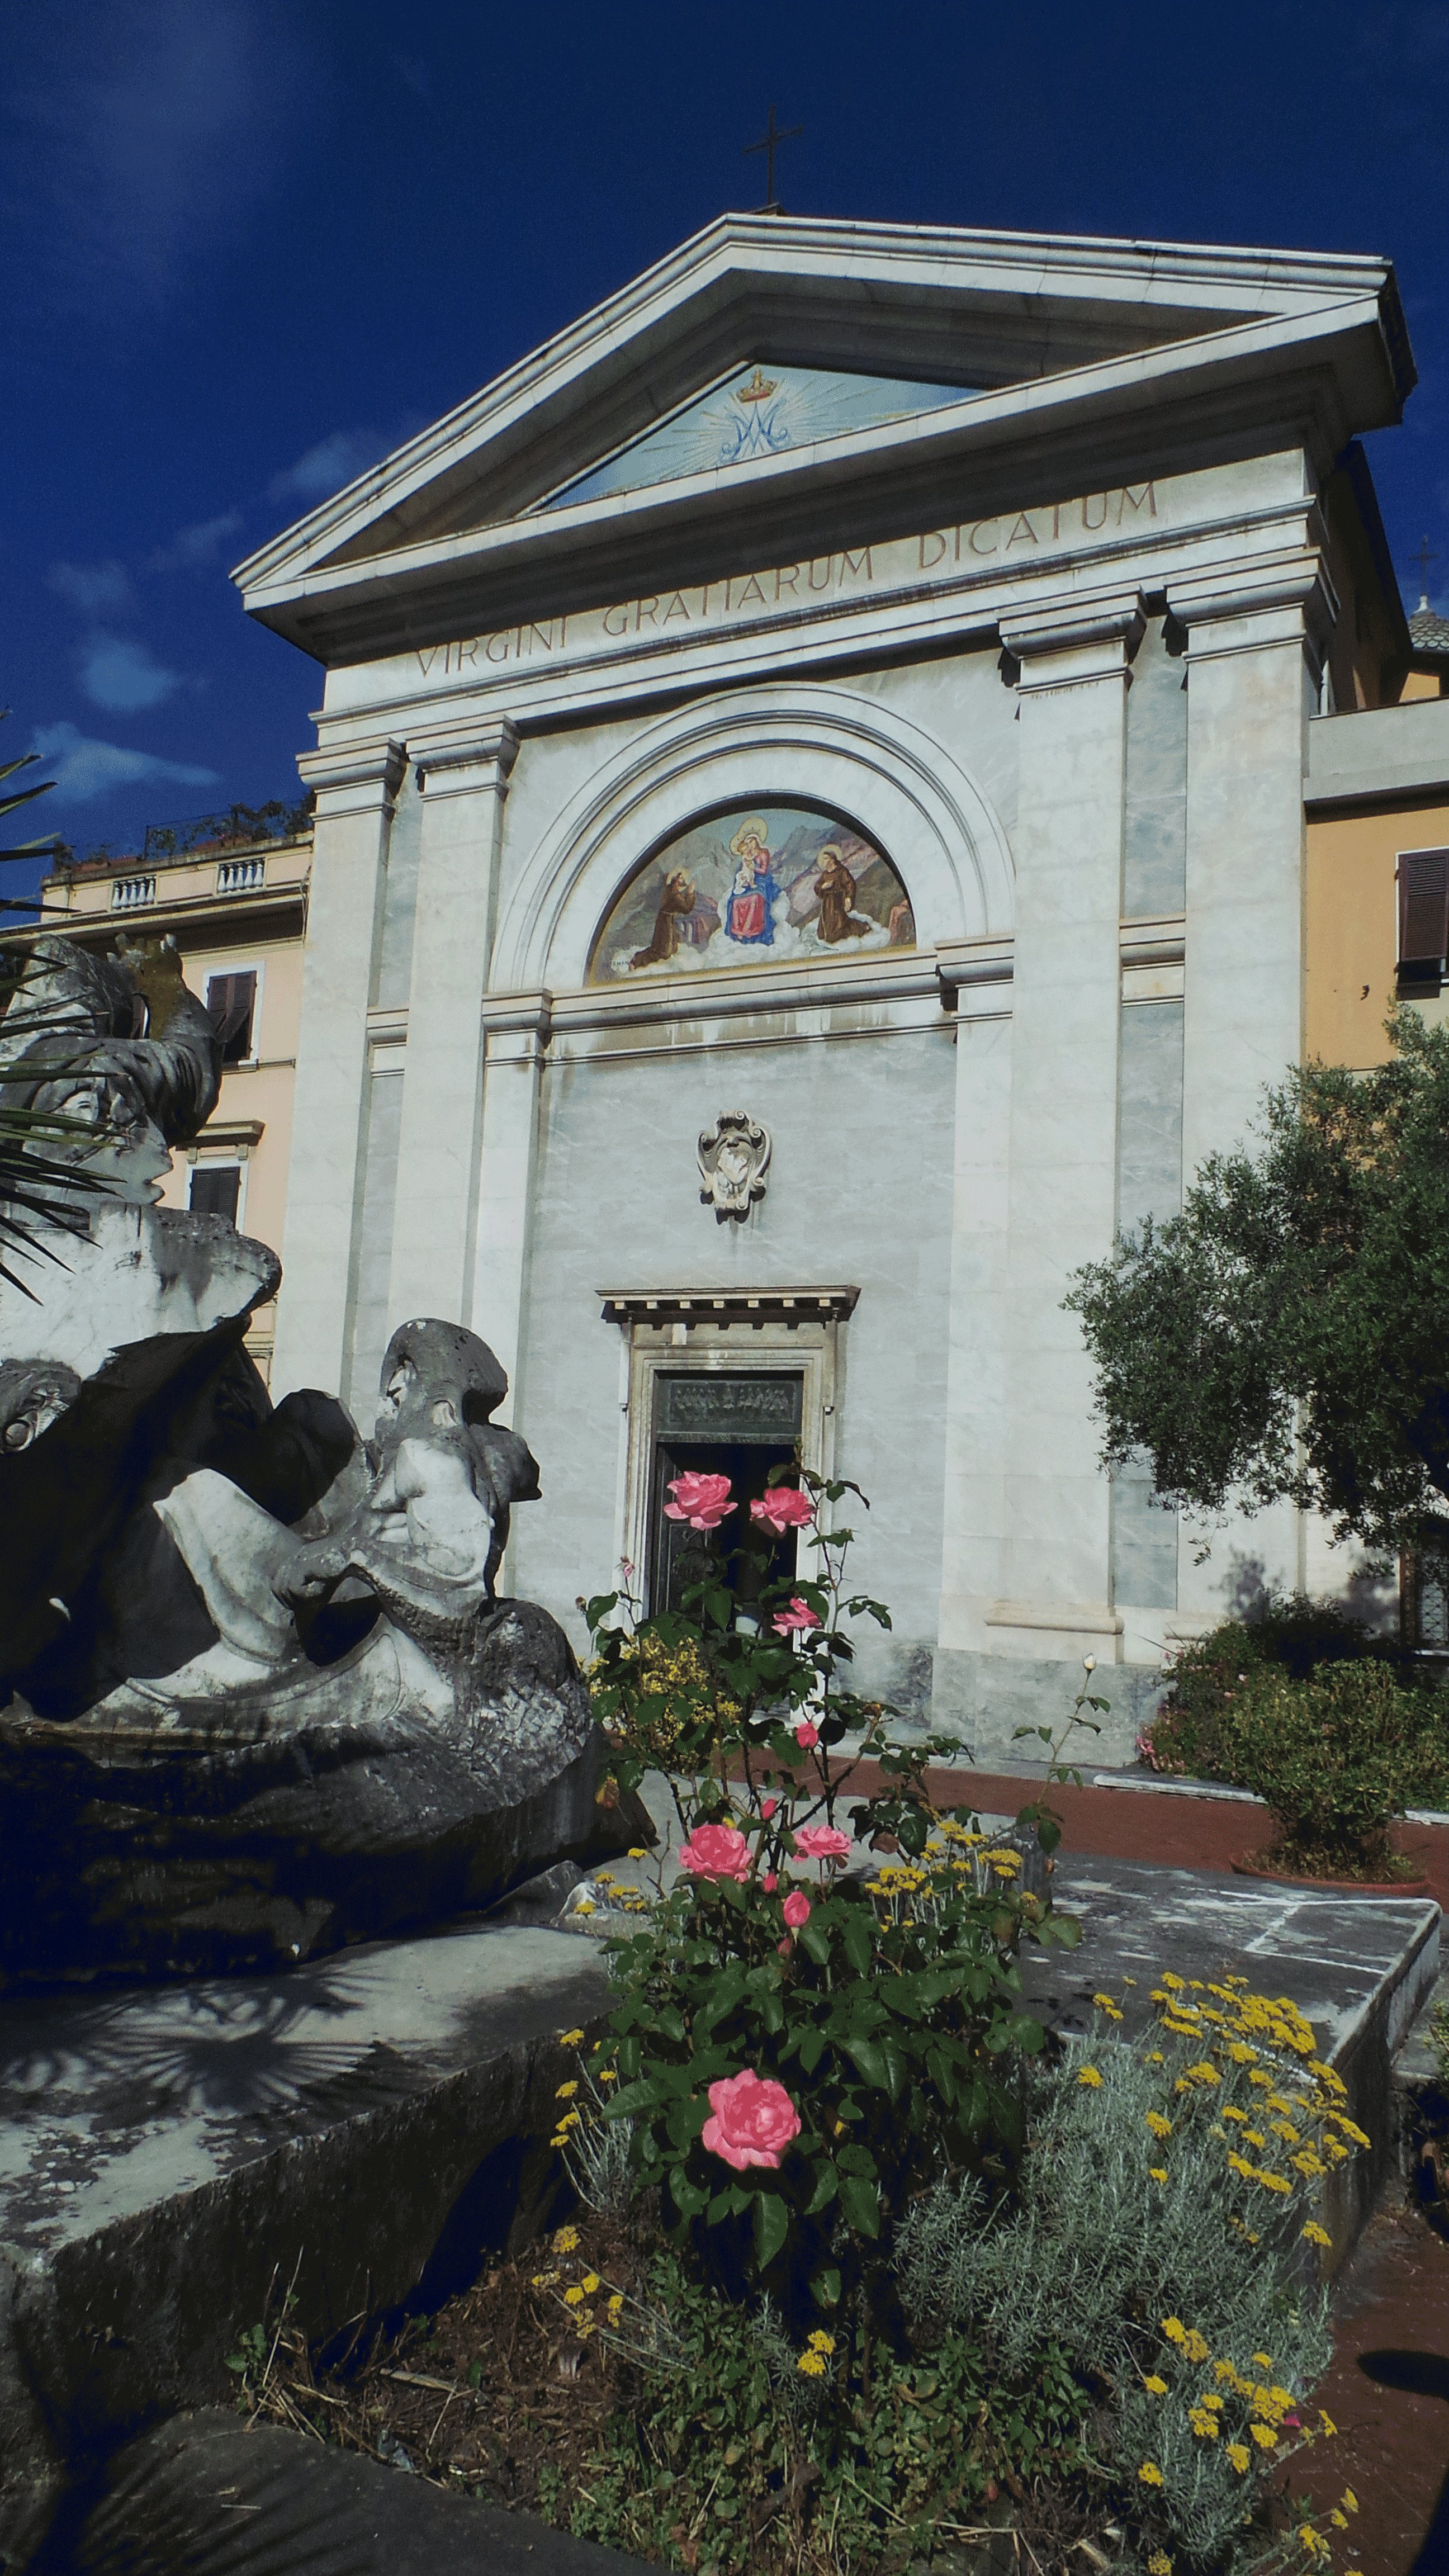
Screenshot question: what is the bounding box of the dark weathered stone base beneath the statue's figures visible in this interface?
[0,1689,647,1991]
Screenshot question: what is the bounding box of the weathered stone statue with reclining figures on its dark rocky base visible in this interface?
[0,937,637,1981]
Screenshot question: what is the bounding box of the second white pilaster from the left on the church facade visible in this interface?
[389,724,518,1324]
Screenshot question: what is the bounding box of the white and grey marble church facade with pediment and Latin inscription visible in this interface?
[237,216,1413,1754]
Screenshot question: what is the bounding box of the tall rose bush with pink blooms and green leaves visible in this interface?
[588,1476,1078,2318]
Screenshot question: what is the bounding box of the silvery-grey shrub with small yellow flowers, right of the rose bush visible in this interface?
[897,1978,1366,2566]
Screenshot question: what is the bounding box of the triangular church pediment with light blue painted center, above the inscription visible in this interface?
[235,216,1413,660]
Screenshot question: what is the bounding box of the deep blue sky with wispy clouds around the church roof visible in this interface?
[0,0,1449,891]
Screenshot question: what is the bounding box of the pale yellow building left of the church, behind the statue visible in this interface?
[41,825,312,1376]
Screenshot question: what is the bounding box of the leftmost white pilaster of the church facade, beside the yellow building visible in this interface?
[271,742,408,1396]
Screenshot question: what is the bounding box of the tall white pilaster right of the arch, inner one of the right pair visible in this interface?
[982,590,1145,1656]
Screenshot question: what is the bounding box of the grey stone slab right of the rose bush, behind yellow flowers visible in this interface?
[1024,1857,1439,2272]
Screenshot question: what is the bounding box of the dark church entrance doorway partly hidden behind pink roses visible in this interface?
[650,1370,804,1620]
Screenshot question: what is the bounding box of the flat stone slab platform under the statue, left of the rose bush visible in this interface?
[0,1919,606,2558]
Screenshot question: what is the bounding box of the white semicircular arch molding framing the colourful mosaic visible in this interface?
[493,685,1014,992]
